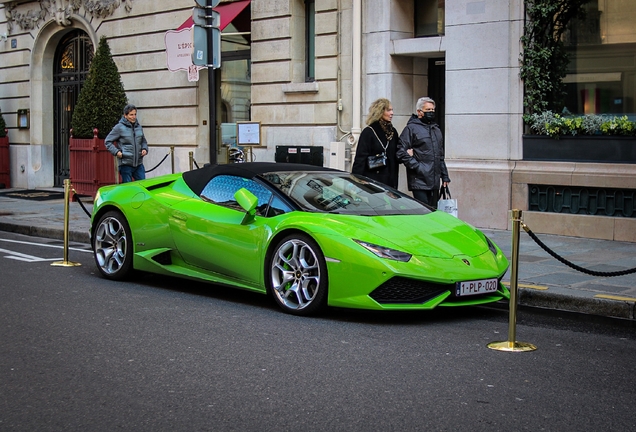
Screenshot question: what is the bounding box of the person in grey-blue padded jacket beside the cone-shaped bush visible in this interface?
[104,104,148,183]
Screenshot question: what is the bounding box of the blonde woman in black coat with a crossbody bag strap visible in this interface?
[351,98,399,189]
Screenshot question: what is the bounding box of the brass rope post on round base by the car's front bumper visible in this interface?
[488,210,537,352]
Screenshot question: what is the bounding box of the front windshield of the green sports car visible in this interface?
[262,171,431,216]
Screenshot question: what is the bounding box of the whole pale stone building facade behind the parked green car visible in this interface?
[0,0,636,241]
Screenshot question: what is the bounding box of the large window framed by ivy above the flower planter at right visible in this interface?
[563,0,636,119]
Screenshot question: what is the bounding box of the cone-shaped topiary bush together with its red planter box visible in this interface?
[69,36,128,197]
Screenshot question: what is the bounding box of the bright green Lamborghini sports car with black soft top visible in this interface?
[91,162,509,315]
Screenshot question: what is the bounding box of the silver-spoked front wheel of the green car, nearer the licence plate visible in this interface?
[269,234,328,315]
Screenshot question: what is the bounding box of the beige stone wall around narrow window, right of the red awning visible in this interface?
[252,0,351,164]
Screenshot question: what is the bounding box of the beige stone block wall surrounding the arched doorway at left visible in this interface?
[0,0,201,188]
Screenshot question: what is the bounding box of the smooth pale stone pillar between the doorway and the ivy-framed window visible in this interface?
[445,0,523,229]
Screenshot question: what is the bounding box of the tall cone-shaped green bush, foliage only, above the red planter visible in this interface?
[71,36,128,138]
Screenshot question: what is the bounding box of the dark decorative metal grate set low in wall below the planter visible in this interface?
[528,185,636,218]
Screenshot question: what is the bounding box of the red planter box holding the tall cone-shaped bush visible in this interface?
[69,129,119,198]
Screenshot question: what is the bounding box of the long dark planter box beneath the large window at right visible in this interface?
[523,135,636,164]
